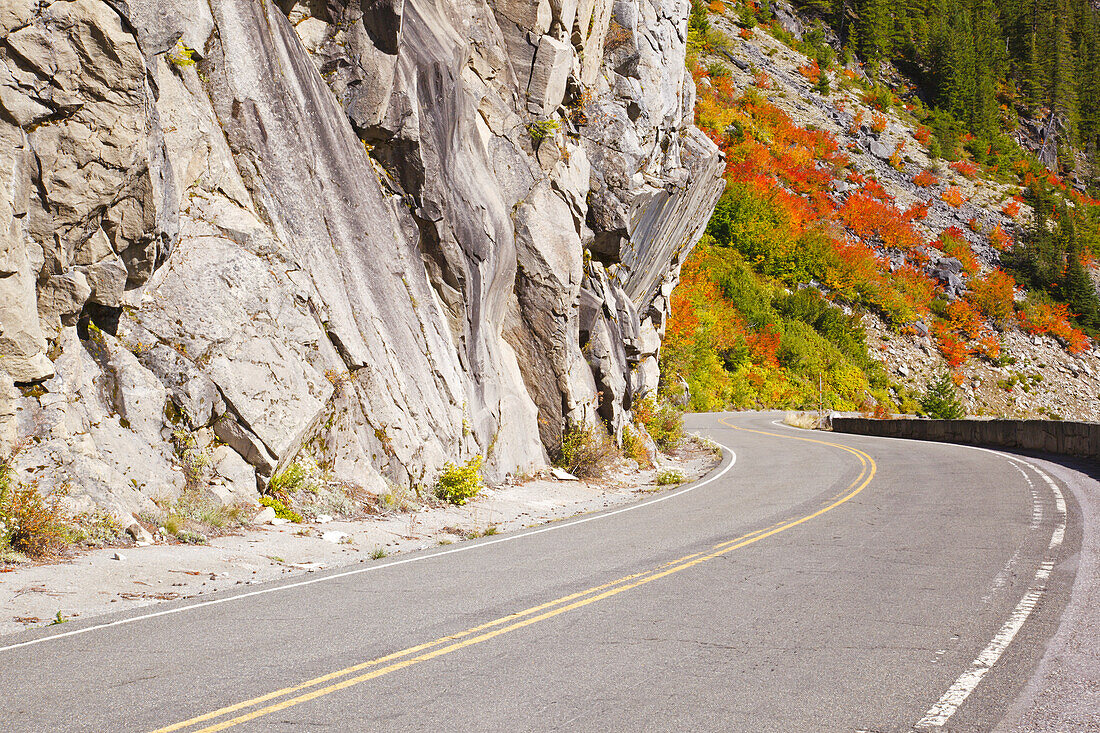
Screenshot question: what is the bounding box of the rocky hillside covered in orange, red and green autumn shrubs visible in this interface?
[662,2,1100,420]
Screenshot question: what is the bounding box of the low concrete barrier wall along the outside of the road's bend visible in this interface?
[833,416,1100,460]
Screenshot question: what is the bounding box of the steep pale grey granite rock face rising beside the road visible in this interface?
[0,0,722,514]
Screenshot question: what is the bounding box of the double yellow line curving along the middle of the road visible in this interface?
[153,418,877,733]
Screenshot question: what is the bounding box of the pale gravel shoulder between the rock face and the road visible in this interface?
[0,441,718,635]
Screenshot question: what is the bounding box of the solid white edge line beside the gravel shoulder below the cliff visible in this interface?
[0,441,737,653]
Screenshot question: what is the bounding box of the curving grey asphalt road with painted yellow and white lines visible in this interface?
[0,414,1080,733]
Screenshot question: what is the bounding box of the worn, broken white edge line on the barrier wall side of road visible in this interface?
[809,422,1067,730]
